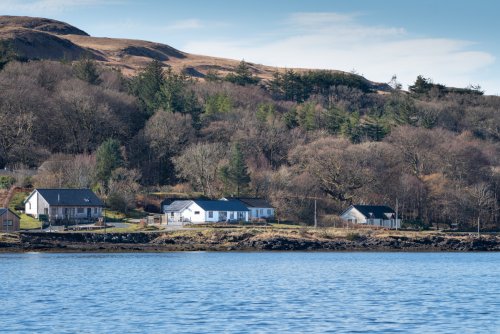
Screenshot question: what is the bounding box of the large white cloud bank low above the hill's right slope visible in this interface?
[183,13,500,93]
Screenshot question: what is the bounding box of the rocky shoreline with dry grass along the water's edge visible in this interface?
[0,229,500,252]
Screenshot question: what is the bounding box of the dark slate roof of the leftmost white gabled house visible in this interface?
[36,189,104,206]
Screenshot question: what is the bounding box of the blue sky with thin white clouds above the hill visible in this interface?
[0,0,500,95]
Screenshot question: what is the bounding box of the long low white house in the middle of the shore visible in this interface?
[165,200,249,225]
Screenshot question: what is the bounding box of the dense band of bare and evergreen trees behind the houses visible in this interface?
[0,57,500,229]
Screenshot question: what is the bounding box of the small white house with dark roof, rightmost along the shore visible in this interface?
[340,205,401,228]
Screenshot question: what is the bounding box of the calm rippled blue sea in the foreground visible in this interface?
[0,252,500,333]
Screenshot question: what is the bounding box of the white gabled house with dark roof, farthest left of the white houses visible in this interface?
[24,189,104,221]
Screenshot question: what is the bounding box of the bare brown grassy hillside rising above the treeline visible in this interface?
[0,16,390,90]
